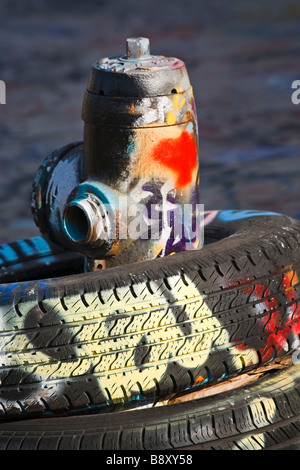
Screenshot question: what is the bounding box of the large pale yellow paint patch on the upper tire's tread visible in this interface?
[2,275,258,401]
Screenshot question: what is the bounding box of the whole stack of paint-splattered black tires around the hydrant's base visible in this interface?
[0,211,300,450]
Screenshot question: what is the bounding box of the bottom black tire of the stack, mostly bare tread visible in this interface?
[0,356,300,452]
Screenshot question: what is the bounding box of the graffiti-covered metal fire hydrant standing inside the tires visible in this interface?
[32,38,201,270]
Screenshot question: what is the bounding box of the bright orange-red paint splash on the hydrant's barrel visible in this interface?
[152,131,197,187]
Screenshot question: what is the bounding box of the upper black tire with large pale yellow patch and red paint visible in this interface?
[0,211,300,420]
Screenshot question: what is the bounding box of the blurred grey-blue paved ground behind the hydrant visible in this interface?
[0,0,300,241]
